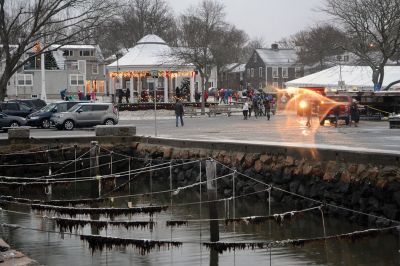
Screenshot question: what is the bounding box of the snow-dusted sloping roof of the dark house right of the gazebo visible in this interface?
[256,48,297,66]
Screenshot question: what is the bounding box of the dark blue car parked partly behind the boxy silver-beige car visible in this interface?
[26,101,86,128]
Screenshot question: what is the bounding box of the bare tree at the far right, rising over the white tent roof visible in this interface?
[324,0,400,89]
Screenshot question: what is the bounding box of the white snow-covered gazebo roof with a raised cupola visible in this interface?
[107,34,192,71]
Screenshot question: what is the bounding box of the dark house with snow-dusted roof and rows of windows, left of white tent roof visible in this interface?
[245,44,304,89]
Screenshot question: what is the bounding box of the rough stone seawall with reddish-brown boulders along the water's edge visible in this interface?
[131,139,400,226]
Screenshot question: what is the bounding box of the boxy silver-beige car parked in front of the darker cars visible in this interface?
[50,103,119,130]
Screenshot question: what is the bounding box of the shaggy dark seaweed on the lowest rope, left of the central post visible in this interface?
[80,235,182,255]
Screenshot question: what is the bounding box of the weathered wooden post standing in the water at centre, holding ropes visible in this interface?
[206,160,219,242]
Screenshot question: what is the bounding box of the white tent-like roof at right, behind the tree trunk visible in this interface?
[286,66,400,89]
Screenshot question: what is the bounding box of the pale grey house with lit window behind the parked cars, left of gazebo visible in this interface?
[7,45,108,100]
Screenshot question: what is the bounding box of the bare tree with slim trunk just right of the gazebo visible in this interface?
[176,0,226,114]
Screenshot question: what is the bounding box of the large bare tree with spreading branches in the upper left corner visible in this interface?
[0,0,115,100]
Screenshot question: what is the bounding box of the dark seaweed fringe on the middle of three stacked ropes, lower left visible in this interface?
[51,217,155,233]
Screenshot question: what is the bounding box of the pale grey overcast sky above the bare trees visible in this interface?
[167,0,326,45]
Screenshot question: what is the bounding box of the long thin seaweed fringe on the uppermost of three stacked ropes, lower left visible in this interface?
[31,204,168,217]
